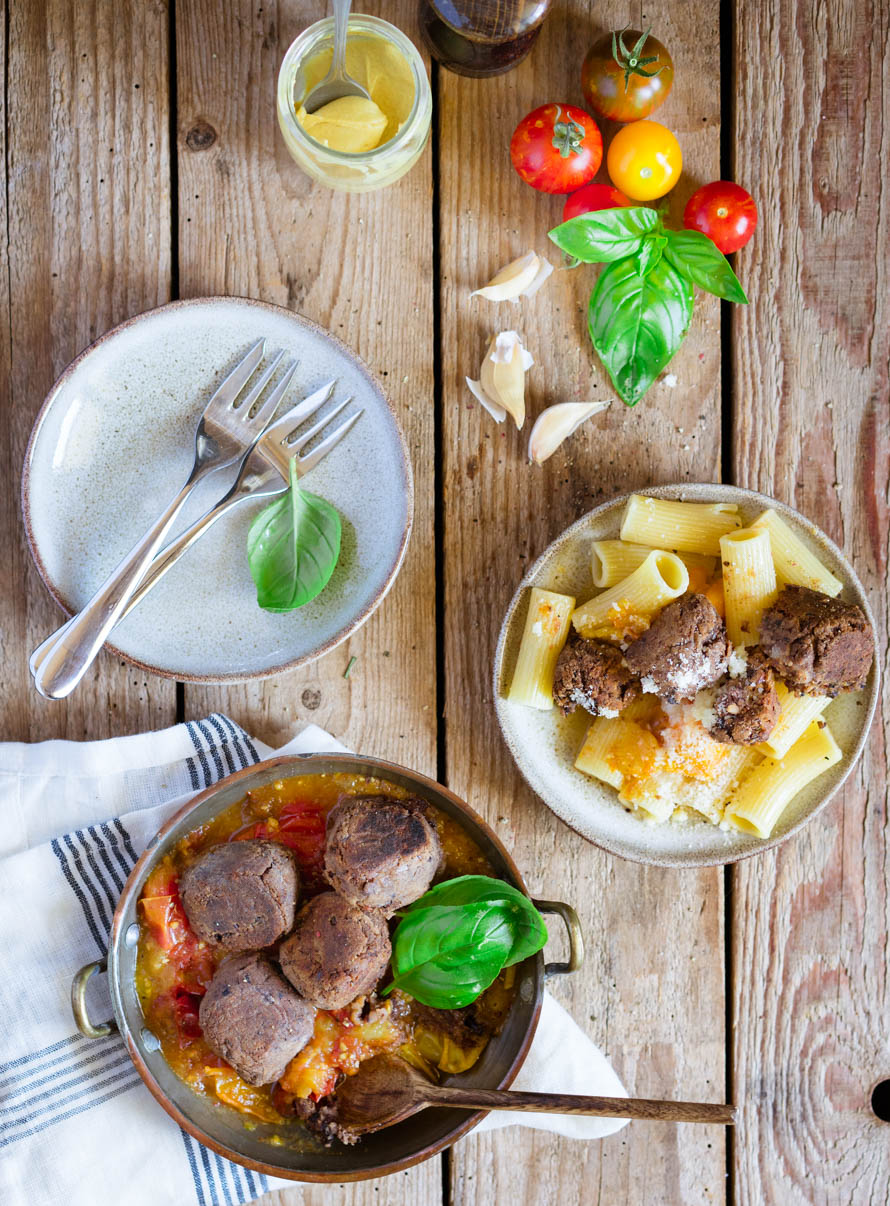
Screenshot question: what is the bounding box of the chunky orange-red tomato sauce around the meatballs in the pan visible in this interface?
[135,774,515,1124]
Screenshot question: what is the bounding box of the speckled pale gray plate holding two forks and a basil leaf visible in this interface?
[22,298,414,681]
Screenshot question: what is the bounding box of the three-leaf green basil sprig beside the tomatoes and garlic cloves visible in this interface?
[550,205,748,406]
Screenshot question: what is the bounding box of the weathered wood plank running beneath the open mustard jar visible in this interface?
[170,0,441,1206]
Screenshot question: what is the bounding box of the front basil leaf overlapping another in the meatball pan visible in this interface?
[385,901,514,1009]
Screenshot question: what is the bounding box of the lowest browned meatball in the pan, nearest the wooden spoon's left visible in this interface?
[198,955,315,1084]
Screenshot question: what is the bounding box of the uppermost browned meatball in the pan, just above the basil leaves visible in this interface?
[324,796,441,917]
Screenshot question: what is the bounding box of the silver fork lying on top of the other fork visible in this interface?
[31,339,291,699]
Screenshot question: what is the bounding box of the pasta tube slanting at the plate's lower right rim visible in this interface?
[724,721,842,837]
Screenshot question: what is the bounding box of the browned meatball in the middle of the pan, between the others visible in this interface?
[279,892,392,1009]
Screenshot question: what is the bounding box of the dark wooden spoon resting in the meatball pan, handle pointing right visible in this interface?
[336,1055,736,1135]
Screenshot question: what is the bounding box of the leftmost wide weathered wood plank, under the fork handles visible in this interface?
[0,0,175,740]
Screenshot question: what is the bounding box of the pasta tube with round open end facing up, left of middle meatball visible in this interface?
[572,549,689,640]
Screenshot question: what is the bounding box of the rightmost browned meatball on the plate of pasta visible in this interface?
[760,586,874,698]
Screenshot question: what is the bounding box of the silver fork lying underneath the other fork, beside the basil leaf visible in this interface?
[30,377,364,674]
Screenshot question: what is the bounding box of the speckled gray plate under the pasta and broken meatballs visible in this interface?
[494,485,878,867]
